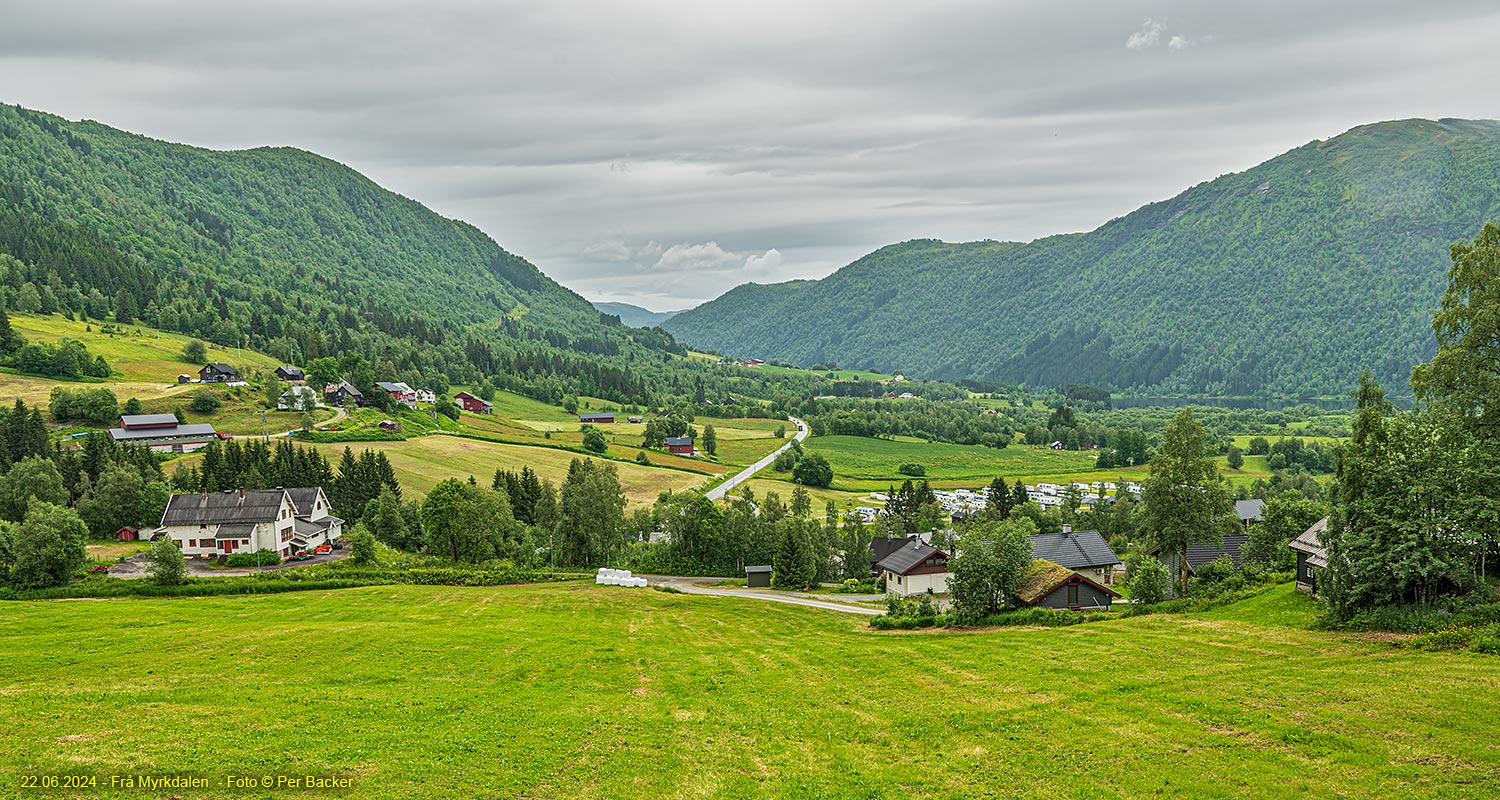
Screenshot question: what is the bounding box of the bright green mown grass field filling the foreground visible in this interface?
[0,584,1500,800]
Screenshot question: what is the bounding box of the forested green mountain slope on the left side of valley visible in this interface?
[0,105,743,402]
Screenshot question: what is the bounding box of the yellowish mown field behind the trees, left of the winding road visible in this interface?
[314,435,707,506]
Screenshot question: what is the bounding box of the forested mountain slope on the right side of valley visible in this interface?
[663,120,1500,396]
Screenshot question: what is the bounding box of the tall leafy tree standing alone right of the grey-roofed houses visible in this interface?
[1142,408,1235,596]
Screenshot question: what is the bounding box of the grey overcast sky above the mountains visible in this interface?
[0,0,1500,311]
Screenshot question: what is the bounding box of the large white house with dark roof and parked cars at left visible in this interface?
[152,488,344,558]
